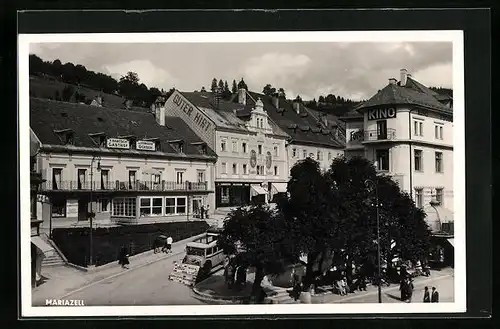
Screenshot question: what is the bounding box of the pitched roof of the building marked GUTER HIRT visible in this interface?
[181,92,288,137]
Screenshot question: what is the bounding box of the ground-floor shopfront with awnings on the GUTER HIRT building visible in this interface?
[215,182,287,208]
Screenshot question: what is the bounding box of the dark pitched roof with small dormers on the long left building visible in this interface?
[30,98,216,158]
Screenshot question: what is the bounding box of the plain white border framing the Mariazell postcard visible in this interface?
[18,30,466,317]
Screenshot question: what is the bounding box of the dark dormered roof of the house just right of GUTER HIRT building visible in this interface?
[243,92,345,148]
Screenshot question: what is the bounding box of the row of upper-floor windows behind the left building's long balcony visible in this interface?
[52,168,206,189]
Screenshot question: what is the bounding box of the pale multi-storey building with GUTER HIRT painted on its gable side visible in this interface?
[153,90,288,209]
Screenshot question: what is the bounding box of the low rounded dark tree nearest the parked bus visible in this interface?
[217,205,296,297]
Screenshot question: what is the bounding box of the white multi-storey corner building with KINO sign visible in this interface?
[342,69,453,231]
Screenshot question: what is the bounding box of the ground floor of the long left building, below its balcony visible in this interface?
[39,191,213,230]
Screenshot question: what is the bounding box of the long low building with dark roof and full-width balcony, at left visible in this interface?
[30,98,216,230]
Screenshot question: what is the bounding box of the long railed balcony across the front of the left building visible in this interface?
[40,180,208,192]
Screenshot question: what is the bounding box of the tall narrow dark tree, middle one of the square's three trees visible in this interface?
[279,158,336,289]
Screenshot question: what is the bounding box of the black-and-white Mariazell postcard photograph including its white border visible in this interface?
[18,31,466,316]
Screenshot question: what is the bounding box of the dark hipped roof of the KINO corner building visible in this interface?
[356,78,453,114]
